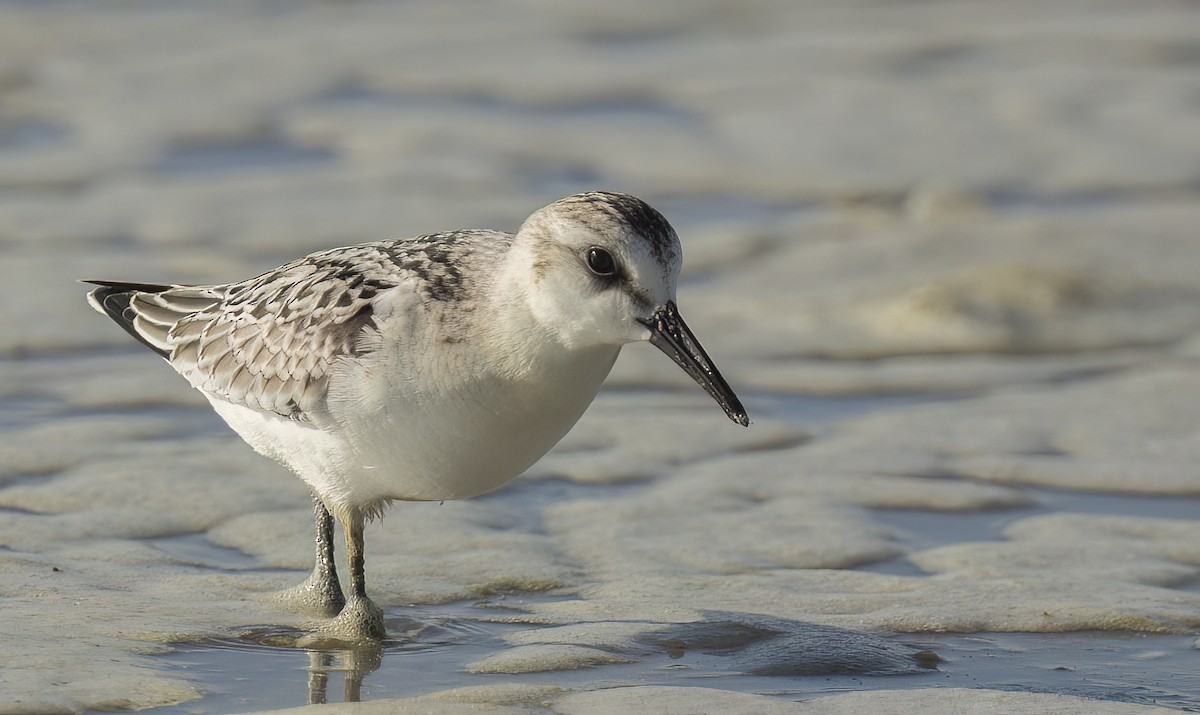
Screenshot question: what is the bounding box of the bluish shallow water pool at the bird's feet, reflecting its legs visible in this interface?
[152,597,1200,713]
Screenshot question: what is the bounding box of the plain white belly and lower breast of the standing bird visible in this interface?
[210,348,619,515]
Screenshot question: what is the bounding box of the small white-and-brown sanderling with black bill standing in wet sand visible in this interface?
[88,192,749,639]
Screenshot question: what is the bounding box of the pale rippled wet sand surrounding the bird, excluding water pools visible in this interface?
[0,0,1200,714]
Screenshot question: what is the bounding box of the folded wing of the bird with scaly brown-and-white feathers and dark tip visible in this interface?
[89,245,400,420]
